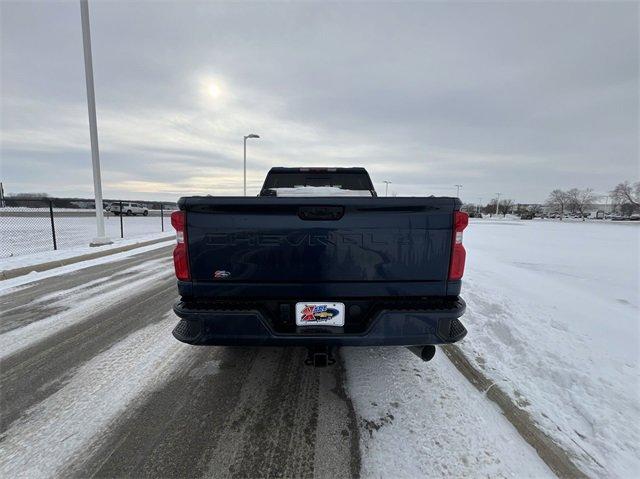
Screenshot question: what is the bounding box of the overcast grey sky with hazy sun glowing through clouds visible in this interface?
[0,0,640,202]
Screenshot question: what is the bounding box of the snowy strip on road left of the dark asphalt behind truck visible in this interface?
[0,313,189,477]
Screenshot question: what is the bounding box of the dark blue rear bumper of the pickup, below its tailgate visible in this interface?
[173,298,467,346]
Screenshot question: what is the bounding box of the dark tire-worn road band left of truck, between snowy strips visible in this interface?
[0,255,175,431]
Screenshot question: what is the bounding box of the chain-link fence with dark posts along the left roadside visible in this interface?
[0,198,175,259]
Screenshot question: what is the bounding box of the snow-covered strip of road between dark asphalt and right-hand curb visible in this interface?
[343,347,554,478]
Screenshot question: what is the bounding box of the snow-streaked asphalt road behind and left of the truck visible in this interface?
[0,247,360,477]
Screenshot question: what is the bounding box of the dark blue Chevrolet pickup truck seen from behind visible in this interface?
[171,168,468,366]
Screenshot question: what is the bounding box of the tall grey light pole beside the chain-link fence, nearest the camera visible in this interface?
[80,0,111,246]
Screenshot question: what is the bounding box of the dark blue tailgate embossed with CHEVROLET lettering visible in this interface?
[180,197,460,286]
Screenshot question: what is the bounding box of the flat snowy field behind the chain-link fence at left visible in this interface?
[0,216,173,260]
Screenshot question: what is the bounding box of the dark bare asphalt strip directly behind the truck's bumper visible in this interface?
[69,346,360,478]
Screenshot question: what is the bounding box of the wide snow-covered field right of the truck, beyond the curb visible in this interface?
[461,219,640,477]
